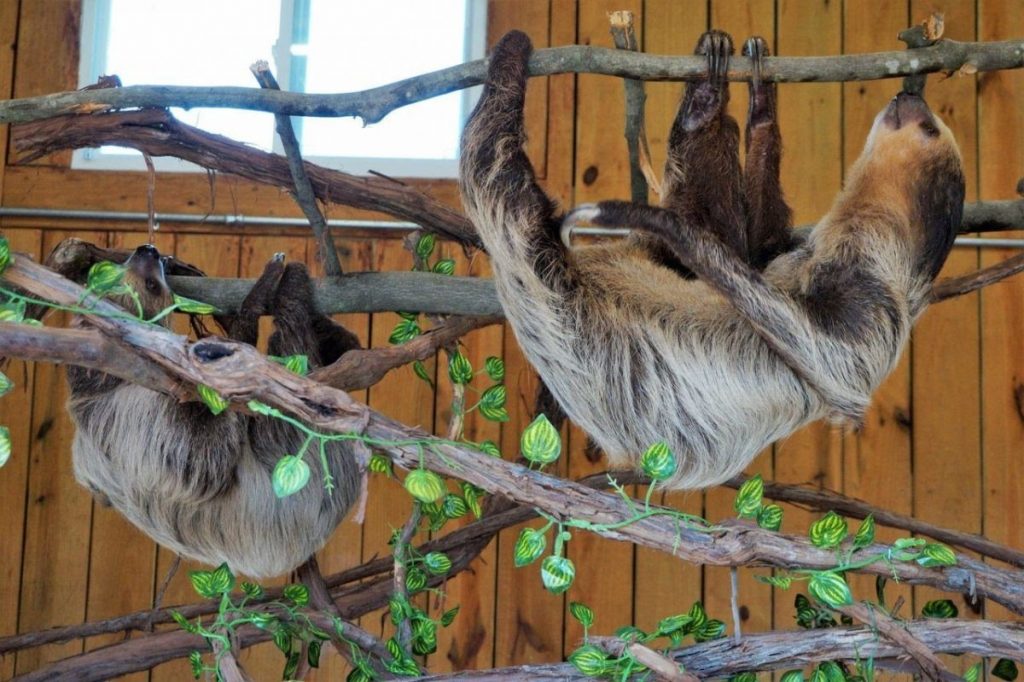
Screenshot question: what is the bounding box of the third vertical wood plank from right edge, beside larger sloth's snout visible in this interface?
[843,0,912,605]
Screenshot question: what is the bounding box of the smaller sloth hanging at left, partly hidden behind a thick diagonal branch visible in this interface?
[68,246,360,578]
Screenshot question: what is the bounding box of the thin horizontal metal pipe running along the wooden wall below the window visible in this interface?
[0,206,1024,249]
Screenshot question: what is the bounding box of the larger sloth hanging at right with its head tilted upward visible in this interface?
[461,32,964,488]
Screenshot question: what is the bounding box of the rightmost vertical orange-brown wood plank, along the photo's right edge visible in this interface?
[978,0,1024,619]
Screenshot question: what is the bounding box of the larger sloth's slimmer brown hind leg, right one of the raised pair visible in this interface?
[743,36,794,269]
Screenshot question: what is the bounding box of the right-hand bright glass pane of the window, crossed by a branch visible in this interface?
[302,0,466,159]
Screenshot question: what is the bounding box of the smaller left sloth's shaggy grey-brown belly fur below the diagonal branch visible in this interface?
[69,385,358,578]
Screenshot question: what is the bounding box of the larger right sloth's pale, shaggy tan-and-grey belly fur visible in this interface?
[497,250,825,488]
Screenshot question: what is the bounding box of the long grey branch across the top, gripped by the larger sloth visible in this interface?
[0,39,1024,123]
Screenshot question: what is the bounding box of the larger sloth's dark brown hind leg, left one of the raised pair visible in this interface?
[662,31,749,260]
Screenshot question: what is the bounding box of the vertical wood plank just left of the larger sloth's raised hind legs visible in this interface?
[630,0,708,632]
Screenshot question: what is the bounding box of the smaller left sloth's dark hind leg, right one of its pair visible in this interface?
[268,263,359,367]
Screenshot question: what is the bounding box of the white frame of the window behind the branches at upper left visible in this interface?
[72,0,487,178]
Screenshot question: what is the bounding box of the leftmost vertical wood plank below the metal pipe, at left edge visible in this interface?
[0,229,41,680]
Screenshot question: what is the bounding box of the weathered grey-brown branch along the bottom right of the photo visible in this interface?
[420,620,1024,682]
